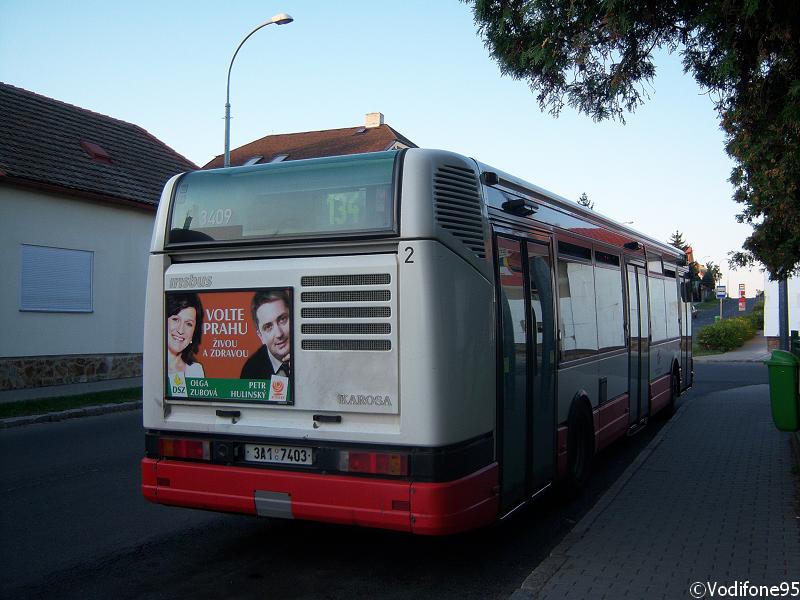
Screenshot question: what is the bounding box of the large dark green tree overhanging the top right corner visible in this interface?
[464,0,800,279]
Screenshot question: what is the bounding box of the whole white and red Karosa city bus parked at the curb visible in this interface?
[142,149,692,535]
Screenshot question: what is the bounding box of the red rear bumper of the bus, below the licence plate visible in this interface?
[142,458,498,535]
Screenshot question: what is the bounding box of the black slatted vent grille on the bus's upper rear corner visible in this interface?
[433,165,486,259]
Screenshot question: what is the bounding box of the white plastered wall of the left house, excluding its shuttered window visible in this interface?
[0,185,155,357]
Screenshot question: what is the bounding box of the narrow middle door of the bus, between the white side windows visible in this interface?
[627,263,650,427]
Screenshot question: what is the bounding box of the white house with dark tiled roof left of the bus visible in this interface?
[0,83,197,392]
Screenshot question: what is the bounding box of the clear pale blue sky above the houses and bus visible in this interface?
[0,0,763,295]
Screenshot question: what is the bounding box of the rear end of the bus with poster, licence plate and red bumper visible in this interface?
[142,149,498,535]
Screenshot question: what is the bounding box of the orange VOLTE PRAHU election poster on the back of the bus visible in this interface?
[165,288,294,404]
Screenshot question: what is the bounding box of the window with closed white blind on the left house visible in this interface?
[19,244,94,312]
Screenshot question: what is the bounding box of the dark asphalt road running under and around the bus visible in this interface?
[0,364,766,600]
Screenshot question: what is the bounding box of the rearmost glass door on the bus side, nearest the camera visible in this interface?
[496,236,555,512]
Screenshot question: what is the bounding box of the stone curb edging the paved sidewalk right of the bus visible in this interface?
[509,401,689,600]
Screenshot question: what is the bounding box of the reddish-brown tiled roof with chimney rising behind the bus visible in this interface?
[203,112,417,169]
